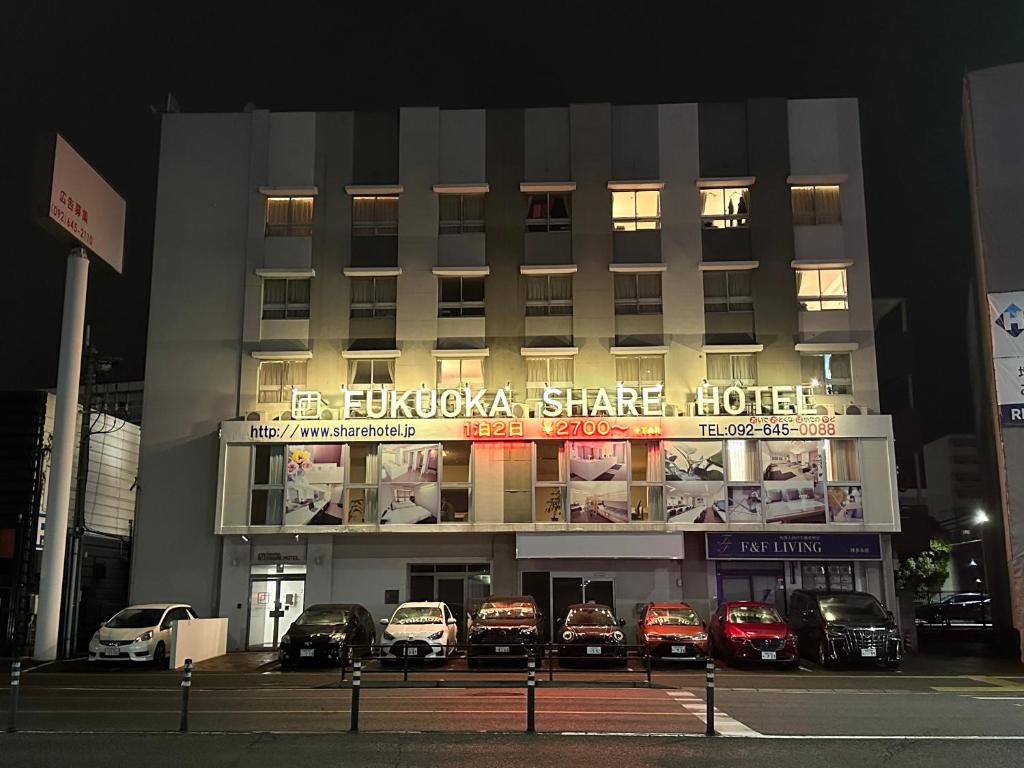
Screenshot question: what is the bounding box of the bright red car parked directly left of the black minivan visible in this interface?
[709,602,800,670]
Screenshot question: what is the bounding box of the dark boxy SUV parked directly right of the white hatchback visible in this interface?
[466,595,544,667]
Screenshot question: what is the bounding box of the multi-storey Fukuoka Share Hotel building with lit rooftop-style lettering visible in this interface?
[132,94,899,648]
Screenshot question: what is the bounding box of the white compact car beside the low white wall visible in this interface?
[89,603,198,667]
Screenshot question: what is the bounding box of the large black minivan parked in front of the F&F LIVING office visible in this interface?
[790,590,903,670]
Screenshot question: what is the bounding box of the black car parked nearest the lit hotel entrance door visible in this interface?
[278,603,377,667]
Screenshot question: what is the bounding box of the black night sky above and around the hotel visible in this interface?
[0,0,1024,439]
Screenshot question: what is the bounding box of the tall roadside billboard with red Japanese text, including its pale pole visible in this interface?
[33,134,125,660]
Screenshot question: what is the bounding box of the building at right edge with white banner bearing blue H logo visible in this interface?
[964,63,1024,657]
